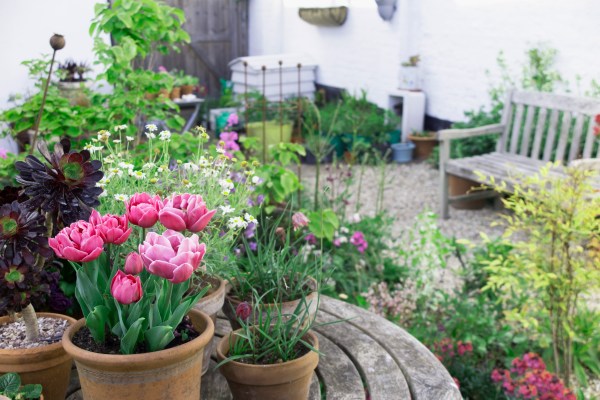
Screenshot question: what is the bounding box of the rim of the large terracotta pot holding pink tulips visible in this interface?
[63,308,215,369]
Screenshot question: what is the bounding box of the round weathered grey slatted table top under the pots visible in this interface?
[67,296,462,400]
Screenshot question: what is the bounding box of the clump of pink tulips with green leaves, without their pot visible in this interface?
[49,193,210,354]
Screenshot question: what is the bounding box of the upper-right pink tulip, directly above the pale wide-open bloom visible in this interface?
[158,193,217,232]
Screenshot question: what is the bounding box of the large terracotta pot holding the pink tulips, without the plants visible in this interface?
[63,309,215,400]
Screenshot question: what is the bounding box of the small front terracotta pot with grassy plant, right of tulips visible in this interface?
[217,292,319,400]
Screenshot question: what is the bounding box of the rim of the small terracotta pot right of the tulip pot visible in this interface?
[216,329,319,378]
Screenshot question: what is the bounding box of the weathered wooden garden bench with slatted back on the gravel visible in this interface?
[437,91,600,219]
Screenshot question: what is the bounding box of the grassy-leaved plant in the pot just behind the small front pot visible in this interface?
[223,216,321,329]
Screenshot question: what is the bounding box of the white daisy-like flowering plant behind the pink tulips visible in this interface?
[86,124,262,273]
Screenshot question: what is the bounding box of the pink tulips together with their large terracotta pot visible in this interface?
[49,193,214,400]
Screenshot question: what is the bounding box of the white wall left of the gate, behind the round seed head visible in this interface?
[0,0,99,109]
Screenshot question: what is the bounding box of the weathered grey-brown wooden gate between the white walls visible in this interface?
[155,0,248,97]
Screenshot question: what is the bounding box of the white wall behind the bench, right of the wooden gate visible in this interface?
[250,0,600,120]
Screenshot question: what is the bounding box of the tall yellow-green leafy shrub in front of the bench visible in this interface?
[483,164,600,382]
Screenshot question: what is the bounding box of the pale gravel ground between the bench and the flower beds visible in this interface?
[302,163,502,241]
